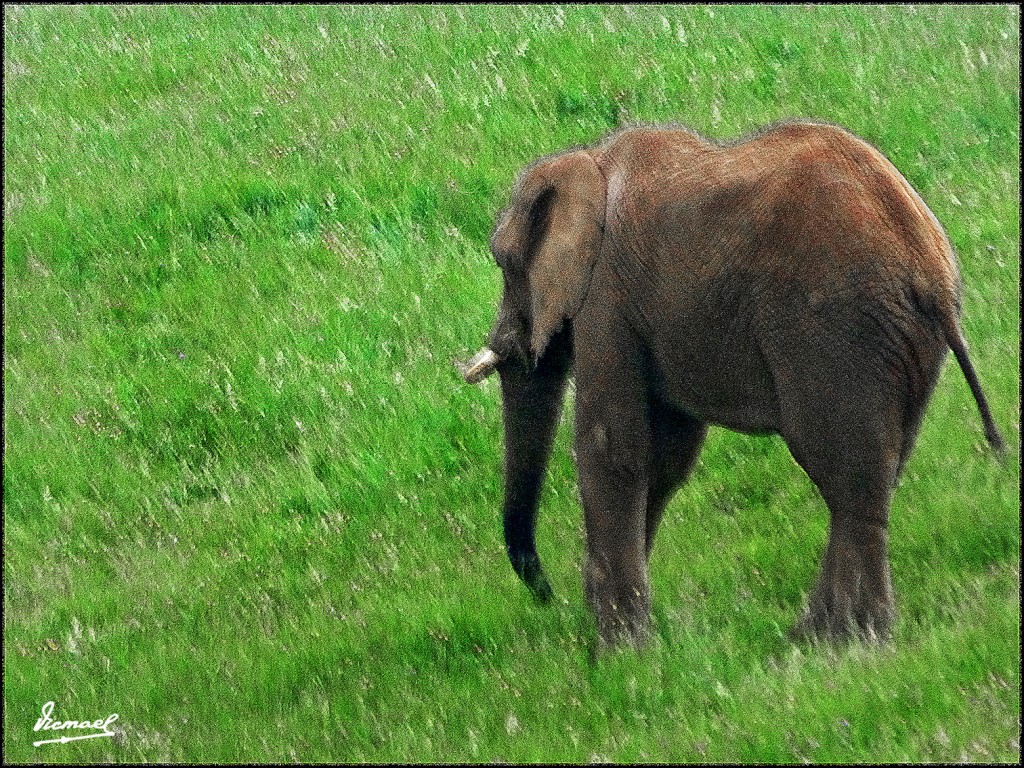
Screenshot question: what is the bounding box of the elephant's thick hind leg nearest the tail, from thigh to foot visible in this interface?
[773,304,945,638]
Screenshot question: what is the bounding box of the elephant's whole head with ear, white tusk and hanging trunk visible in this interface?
[463,152,605,600]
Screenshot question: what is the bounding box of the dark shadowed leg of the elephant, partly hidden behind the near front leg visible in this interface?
[646,400,708,558]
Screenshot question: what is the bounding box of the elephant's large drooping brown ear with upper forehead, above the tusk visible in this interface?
[492,152,606,362]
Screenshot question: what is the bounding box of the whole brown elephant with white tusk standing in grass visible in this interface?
[461,121,1005,648]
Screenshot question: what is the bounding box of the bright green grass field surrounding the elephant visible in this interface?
[3,5,1020,763]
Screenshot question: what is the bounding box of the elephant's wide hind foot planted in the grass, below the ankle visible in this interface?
[790,523,896,642]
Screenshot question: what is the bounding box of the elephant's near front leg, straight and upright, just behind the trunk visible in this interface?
[577,384,650,646]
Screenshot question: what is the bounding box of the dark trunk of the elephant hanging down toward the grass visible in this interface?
[498,332,571,602]
